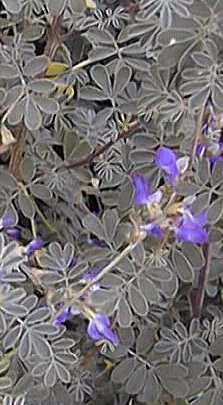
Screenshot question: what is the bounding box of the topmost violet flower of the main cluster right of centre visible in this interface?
[155,147,179,185]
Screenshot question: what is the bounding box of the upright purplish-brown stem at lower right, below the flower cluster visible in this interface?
[192,244,211,318]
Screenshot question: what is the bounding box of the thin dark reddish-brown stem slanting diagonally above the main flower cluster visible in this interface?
[58,121,140,170]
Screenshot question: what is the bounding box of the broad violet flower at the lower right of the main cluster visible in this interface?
[175,210,208,245]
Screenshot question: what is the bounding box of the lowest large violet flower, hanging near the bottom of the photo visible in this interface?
[87,314,118,346]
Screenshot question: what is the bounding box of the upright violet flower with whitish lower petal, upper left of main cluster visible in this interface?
[132,174,162,207]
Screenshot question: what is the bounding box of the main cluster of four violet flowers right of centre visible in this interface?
[132,147,208,245]
